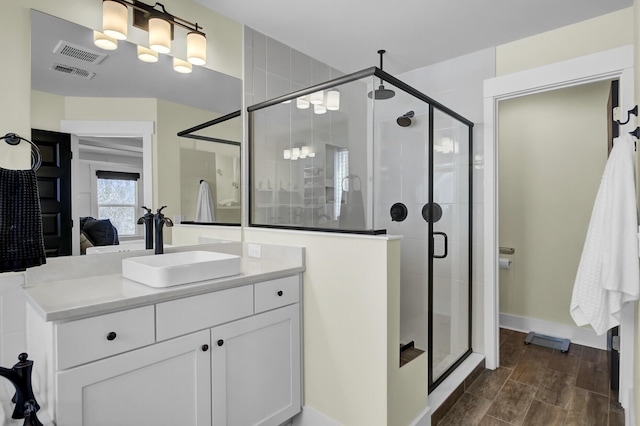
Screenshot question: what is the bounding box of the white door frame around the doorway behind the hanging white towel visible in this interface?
[484,45,636,409]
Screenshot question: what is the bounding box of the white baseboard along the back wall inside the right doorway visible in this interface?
[500,314,607,350]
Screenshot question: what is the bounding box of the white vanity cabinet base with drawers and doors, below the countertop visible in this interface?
[27,275,301,426]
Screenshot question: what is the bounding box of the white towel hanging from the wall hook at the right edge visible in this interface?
[571,135,640,335]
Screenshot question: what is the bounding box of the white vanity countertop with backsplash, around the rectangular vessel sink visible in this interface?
[24,243,305,321]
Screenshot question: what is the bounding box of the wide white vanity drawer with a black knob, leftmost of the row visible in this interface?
[56,306,155,370]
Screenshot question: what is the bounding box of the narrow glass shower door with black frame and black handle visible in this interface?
[422,106,472,391]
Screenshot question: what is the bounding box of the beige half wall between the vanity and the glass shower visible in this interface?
[235,228,427,426]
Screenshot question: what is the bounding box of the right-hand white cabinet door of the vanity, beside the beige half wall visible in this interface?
[211,304,301,426]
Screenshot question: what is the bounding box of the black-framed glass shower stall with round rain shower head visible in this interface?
[248,64,473,392]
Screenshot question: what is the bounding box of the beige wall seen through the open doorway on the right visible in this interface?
[498,82,610,325]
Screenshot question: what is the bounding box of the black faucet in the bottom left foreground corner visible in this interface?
[0,352,42,426]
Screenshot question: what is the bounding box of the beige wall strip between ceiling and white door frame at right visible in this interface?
[496,8,637,75]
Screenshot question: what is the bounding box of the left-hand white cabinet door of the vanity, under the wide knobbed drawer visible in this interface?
[56,330,211,426]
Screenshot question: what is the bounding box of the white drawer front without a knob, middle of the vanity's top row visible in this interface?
[156,285,253,340]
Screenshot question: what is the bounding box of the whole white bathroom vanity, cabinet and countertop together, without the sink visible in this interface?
[25,243,304,426]
